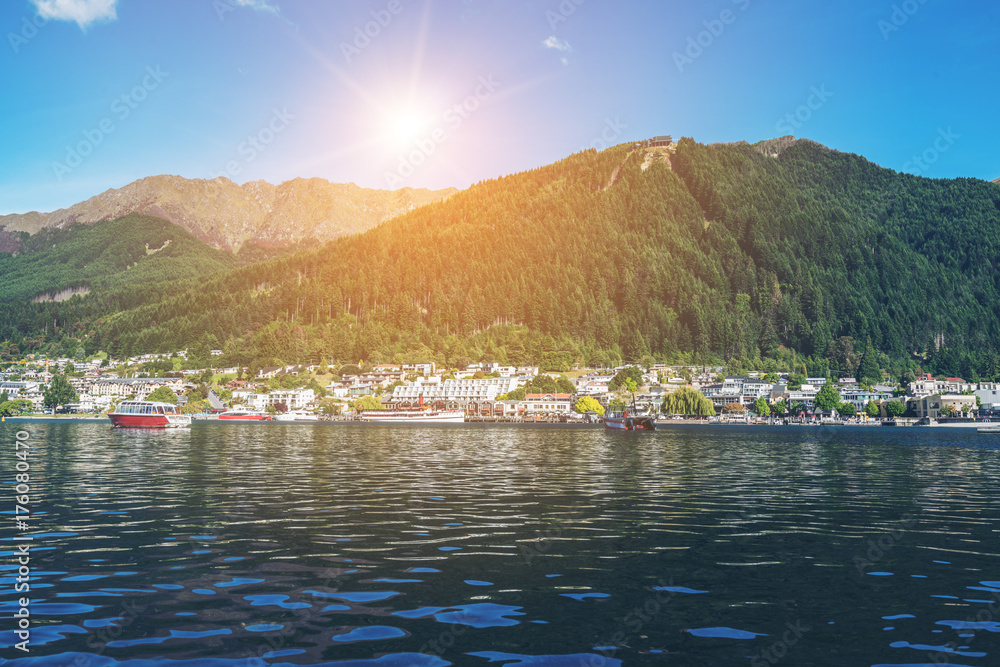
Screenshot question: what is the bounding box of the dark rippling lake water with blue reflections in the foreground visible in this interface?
[0,422,1000,667]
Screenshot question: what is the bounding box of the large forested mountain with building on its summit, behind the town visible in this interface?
[0,138,1000,379]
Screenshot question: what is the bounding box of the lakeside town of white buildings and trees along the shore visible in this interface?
[0,350,1000,424]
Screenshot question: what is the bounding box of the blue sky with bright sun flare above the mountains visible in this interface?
[0,0,1000,214]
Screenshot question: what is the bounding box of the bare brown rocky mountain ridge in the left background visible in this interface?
[0,176,457,252]
